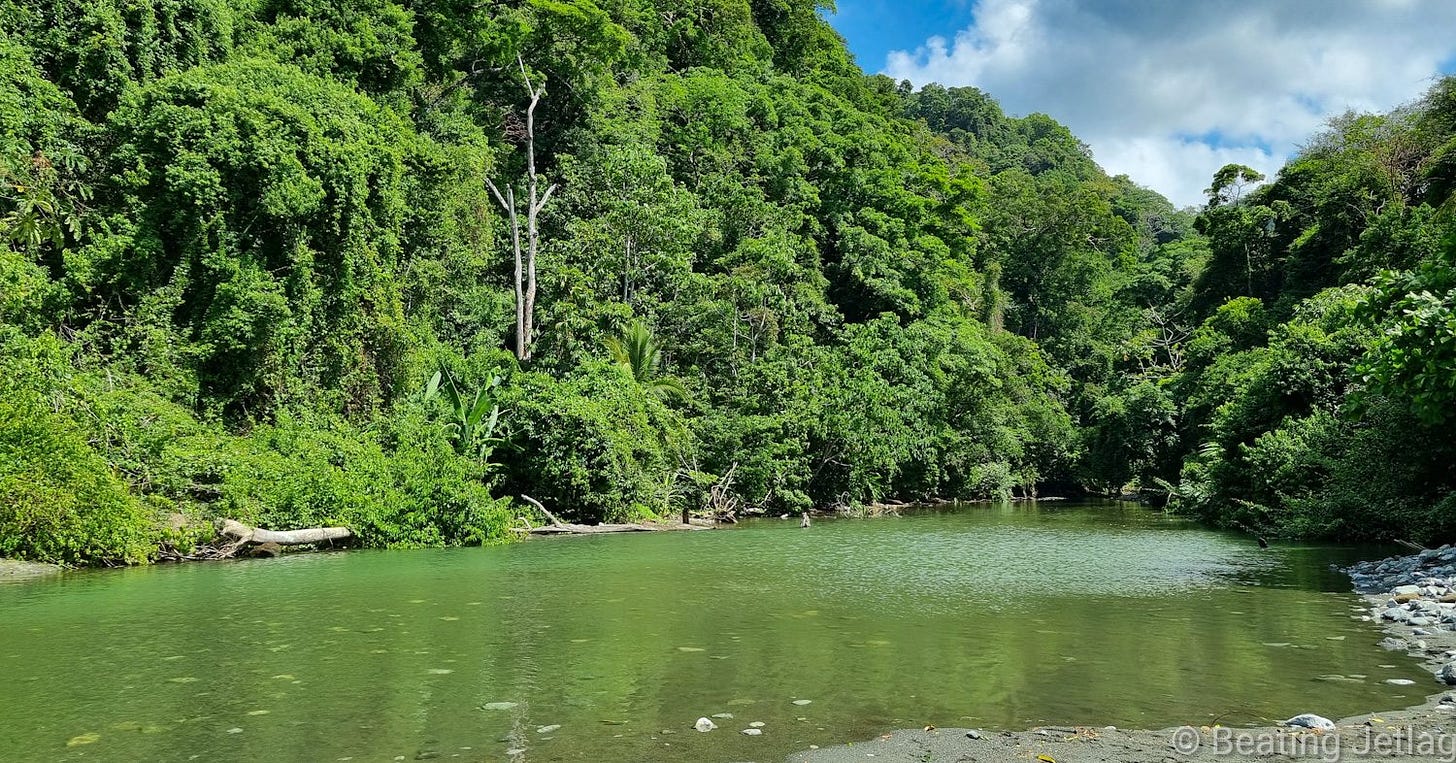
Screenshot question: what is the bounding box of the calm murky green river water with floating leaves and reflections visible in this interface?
[0,502,1436,762]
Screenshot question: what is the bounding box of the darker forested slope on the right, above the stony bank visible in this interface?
[1142,79,1456,542]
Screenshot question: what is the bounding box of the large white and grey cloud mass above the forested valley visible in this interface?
[884,0,1456,205]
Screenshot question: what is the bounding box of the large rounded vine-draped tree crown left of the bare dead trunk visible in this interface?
[100,60,422,414]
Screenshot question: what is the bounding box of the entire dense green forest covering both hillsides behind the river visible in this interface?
[0,0,1456,564]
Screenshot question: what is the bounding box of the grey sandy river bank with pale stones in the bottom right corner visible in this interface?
[788,546,1456,763]
